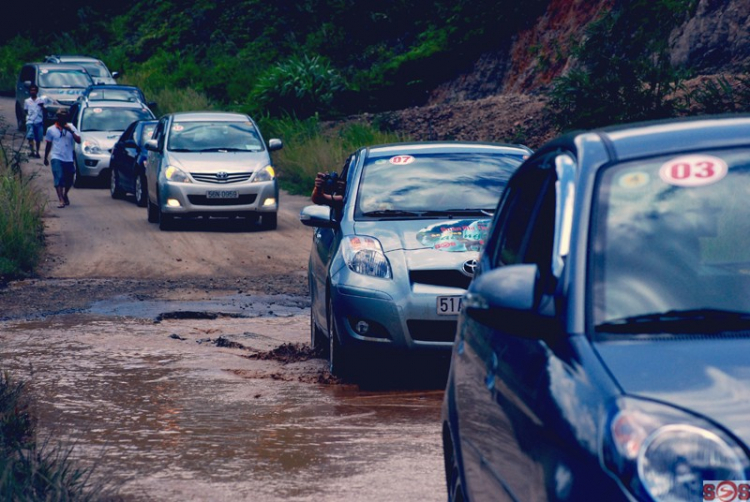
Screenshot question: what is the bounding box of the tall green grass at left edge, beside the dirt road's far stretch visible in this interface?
[0,124,45,283]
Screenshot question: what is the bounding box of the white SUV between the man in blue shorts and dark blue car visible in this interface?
[71,101,155,187]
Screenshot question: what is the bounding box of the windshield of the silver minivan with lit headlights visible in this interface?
[167,121,263,152]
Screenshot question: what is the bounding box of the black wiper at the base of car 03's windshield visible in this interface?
[596,309,750,334]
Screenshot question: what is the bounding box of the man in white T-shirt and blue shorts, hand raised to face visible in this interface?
[44,110,81,208]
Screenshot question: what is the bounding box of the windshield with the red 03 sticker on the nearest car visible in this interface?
[589,149,750,333]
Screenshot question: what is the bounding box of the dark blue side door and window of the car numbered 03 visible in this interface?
[453,156,556,501]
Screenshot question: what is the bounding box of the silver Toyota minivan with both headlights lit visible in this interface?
[146,112,283,230]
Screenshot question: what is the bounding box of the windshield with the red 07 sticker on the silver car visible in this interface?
[356,149,528,219]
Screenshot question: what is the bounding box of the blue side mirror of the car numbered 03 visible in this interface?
[463,264,559,338]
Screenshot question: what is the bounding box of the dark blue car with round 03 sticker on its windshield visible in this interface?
[442,116,750,502]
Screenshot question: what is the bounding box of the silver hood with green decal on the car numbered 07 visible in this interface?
[354,218,491,253]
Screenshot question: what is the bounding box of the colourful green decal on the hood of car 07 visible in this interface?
[417,219,492,253]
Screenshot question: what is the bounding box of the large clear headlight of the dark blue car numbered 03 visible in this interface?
[602,398,750,501]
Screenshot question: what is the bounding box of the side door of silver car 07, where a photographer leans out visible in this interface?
[309,154,357,326]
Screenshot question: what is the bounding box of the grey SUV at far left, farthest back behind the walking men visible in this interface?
[16,63,93,131]
